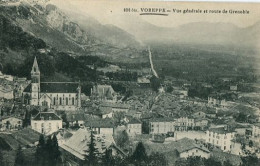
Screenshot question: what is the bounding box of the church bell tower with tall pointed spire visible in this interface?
[31,57,40,105]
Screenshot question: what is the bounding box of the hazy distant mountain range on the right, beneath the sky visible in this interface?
[114,17,260,48]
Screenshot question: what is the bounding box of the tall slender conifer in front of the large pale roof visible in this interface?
[85,130,98,166]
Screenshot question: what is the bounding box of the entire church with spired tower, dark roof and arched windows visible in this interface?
[23,57,81,111]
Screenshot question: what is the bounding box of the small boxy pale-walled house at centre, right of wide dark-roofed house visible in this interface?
[127,118,142,135]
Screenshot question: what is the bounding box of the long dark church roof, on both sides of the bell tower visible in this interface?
[24,82,79,93]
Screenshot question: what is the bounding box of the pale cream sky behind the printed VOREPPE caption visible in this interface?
[51,0,260,27]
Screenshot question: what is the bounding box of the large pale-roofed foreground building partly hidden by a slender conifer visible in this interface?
[60,129,125,165]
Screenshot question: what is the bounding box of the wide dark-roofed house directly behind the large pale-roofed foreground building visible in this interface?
[85,118,115,135]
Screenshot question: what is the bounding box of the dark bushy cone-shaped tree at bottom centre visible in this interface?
[131,142,148,165]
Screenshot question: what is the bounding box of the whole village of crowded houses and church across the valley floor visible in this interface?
[0,57,260,166]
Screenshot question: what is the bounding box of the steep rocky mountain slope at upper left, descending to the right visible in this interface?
[0,0,139,55]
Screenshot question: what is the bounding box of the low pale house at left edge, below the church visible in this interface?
[1,117,23,130]
